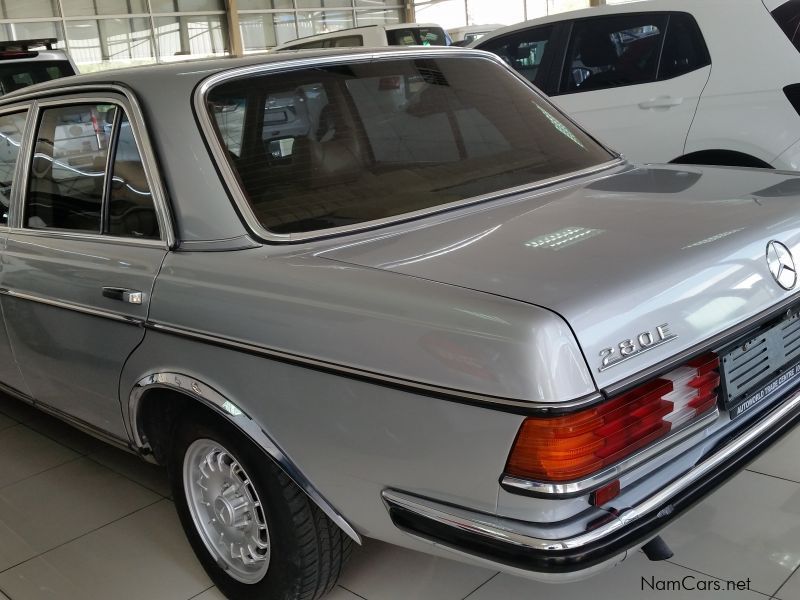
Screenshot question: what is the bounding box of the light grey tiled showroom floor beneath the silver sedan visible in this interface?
[0,396,800,600]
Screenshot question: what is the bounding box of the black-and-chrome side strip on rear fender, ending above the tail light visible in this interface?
[145,320,604,416]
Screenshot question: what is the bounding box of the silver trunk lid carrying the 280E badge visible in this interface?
[323,166,800,388]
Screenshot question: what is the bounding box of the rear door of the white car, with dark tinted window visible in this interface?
[553,13,711,162]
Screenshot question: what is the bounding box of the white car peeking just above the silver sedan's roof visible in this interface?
[274,23,450,50]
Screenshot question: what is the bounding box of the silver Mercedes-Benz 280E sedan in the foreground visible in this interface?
[0,48,800,600]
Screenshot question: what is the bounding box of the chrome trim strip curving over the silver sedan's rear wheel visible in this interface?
[125,372,361,545]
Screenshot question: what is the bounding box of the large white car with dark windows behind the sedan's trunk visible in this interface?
[473,0,800,169]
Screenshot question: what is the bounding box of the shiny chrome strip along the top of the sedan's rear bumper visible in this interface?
[381,389,800,551]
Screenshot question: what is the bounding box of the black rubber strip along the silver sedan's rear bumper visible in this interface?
[389,400,800,573]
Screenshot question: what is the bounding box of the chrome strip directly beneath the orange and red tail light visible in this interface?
[500,408,721,499]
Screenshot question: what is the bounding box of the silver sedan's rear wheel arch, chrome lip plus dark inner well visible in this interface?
[126,372,361,545]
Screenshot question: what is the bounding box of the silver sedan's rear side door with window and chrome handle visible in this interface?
[1,94,169,438]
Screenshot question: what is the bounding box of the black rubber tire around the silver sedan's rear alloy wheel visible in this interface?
[168,414,352,600]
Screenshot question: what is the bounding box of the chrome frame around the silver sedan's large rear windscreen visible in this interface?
[193,47,625,243]
